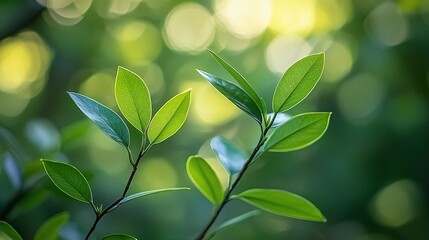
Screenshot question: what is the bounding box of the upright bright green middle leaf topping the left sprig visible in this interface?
[115,67,152,132]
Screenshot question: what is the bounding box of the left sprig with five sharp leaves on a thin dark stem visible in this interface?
[41,67,191,239]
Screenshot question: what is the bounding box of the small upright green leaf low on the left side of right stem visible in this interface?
[186,156,224,205]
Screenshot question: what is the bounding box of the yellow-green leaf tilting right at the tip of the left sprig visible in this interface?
[148,89,191,143]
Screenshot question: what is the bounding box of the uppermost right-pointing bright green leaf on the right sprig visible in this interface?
[273,53,325,112]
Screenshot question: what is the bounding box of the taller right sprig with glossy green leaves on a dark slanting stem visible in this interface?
[187,51,331,240]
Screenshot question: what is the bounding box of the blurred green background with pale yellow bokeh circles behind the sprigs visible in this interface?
[0,0,429,240]
